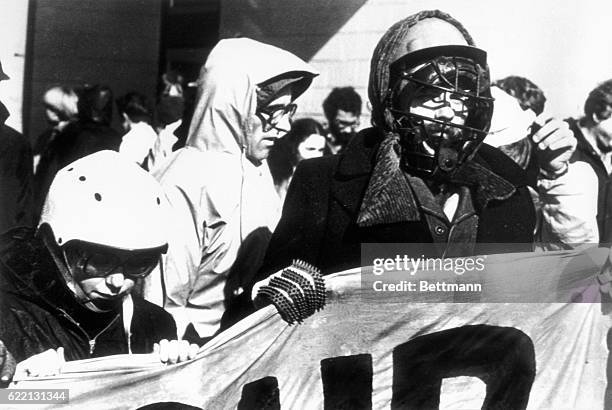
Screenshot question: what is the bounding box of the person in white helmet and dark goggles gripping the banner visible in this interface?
[0,151,197,382]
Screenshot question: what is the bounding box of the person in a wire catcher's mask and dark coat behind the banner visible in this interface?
[252,10,566,278]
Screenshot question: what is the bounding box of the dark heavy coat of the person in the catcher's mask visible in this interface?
[258,129,535,279]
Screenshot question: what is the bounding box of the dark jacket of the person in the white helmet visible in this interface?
[0,228,176,361]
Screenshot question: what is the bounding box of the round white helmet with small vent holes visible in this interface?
[39,151,168,250]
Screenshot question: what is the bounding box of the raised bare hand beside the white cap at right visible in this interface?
[532,114,576,177]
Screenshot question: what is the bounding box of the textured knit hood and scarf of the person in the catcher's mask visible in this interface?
[357,10,514,227]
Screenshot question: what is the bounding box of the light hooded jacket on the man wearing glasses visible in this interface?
[145,39,317,337]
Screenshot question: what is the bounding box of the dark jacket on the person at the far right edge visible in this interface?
[565,118,612,244]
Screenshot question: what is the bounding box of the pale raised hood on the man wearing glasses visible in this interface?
[186,38,318,155]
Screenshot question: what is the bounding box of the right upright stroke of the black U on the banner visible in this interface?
[321,354,372,410]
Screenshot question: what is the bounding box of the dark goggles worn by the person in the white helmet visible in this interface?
[64,244,160,280]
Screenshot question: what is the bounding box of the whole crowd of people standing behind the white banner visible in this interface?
[0,10,612,406]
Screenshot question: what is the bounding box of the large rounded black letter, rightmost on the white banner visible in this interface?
[391,325,535,409]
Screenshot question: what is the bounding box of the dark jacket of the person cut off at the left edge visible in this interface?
[0,103,33,233]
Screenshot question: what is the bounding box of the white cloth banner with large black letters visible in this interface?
[12,249,612,410]
